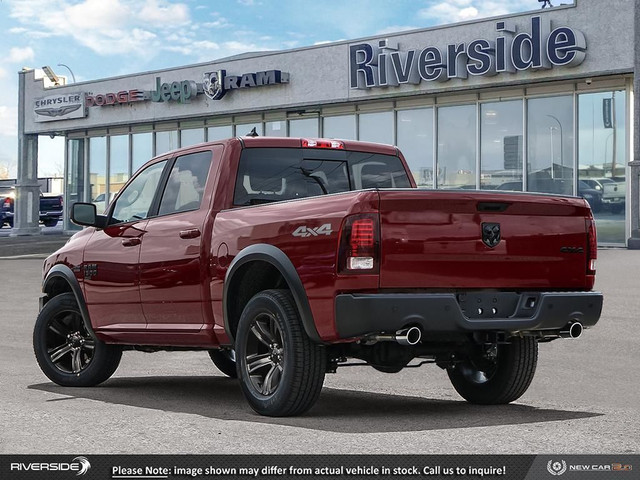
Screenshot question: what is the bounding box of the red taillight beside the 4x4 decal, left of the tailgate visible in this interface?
[338,213,380,273]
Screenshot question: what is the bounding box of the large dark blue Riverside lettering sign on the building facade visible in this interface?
[349,16,587,89]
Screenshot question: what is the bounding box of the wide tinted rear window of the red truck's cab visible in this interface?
[233,148,411,206]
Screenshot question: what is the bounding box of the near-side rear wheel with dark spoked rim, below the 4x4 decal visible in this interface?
[236,290,327,417]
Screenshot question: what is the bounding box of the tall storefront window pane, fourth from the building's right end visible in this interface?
[436,105,476,188]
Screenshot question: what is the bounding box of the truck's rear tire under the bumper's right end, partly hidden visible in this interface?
[447,337,538,405]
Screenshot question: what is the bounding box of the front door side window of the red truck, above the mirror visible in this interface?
[111,160,167,223]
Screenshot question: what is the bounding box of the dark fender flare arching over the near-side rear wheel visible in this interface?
[222,244,323,343]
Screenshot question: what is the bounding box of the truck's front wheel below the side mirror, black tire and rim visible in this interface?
[33,293,122,387]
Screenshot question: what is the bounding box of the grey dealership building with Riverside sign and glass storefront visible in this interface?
[14,0,640,247]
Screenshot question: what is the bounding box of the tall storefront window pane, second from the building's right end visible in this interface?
[527,95,573,195]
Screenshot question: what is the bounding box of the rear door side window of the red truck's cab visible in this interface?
[158,151,212,215]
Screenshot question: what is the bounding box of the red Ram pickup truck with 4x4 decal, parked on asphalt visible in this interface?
[34,137,602,416]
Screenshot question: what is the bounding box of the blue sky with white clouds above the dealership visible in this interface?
[0,0,560,178]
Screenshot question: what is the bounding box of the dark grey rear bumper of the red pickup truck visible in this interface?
[335,292,602,338]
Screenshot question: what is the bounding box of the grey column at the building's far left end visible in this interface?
[11,71,40,236]
